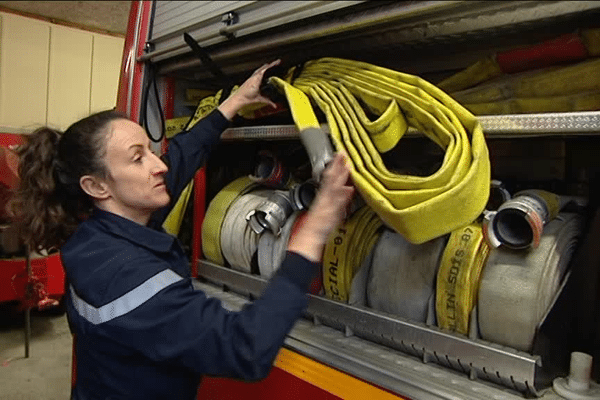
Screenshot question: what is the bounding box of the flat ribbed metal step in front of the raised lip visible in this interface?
[194,281,523,400]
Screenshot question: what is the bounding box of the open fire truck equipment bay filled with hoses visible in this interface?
[131,1,600,399]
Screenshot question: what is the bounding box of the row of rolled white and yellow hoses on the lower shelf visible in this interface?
[203,173,582,351]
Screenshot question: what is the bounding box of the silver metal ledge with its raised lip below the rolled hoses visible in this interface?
[196,261,540,399]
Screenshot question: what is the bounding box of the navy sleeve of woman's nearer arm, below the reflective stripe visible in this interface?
[101,252,320,380]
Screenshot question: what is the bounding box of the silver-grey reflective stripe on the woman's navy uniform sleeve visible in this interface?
[69,269,183,325]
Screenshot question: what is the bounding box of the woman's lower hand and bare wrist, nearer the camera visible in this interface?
[288,153,354,262]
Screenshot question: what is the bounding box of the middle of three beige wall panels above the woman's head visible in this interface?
[48,25,93,129]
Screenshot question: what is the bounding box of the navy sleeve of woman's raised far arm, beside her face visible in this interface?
[152,110,230,226]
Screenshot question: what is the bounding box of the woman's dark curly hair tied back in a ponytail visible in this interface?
[11,110,126,251]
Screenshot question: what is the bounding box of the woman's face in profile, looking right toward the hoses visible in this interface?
[105,119,170,224]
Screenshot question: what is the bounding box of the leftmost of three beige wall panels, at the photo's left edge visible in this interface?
[0,13,50,131]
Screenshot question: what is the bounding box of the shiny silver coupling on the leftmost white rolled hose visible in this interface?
[246,190,294,236]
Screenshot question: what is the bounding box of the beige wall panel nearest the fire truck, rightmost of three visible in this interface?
[90,34,125,113]
